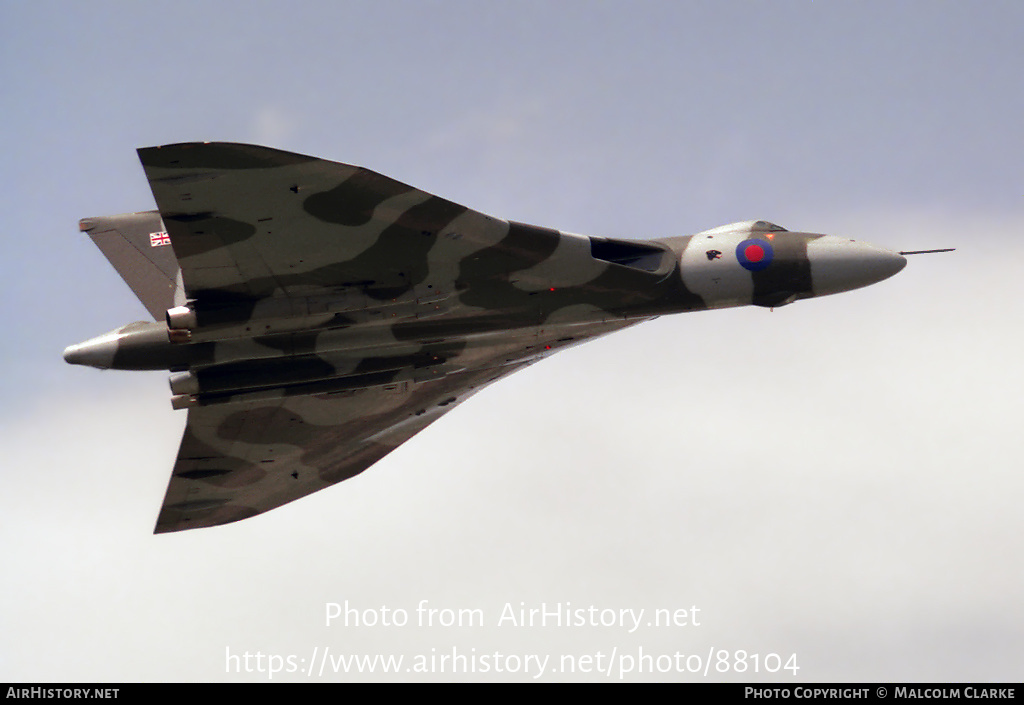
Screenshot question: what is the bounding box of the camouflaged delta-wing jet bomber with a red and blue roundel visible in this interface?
[65,143,906,533]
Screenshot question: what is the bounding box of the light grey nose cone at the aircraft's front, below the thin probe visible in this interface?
[807,235,906,296]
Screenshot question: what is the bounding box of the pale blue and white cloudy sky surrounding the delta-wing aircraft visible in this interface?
[0,0,1024,682]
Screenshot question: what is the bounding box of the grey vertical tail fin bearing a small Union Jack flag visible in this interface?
[78,210,183,321]
